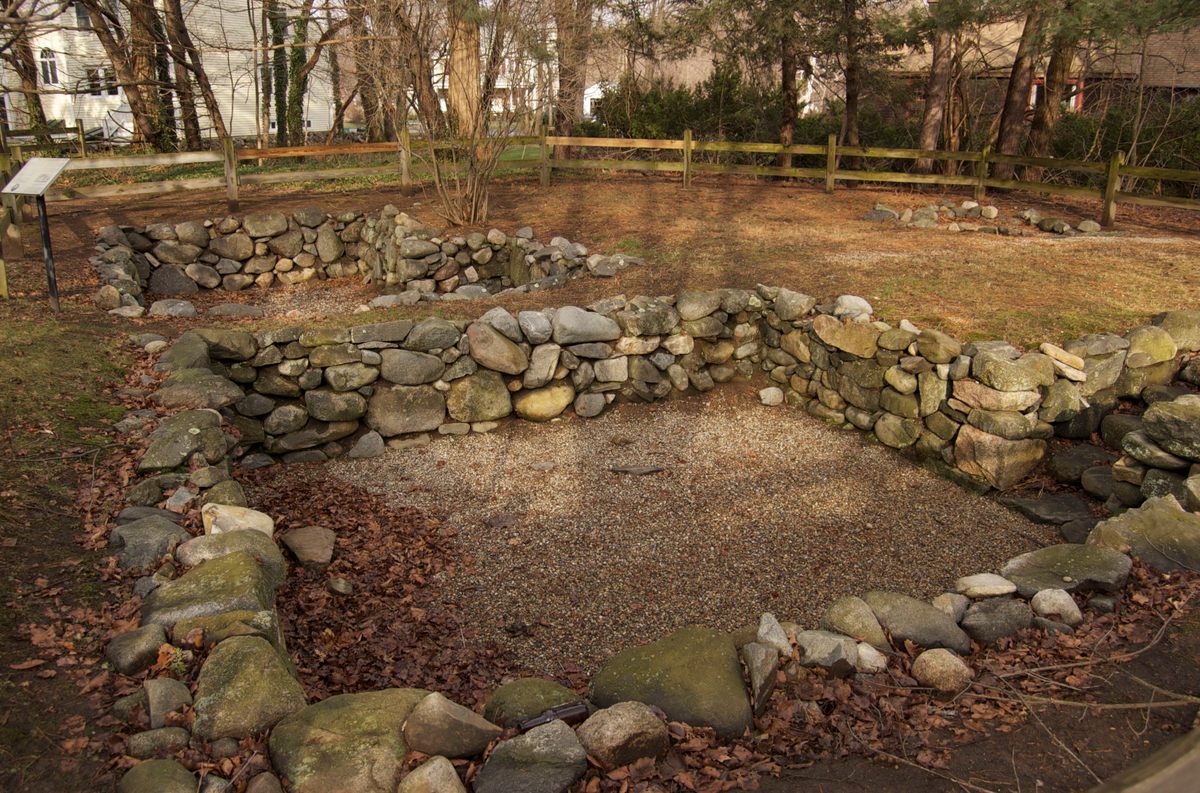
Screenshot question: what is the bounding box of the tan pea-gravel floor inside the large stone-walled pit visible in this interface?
[328,386,1054,674]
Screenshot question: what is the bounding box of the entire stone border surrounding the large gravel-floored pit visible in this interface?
[108,287,1200,793]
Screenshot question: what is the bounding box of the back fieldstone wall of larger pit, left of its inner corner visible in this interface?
[163,289,763,465]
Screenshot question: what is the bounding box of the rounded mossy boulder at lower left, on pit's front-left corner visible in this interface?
[192,636,305,740]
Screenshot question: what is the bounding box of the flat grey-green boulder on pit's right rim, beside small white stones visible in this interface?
[1000,543,1133,597]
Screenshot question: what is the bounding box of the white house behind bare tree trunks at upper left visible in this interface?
[0,0,334,139]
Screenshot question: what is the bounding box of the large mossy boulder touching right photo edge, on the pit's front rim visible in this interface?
[1087,495,1200,571]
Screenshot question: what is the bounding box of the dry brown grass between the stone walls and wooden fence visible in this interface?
[25,175,1200,344]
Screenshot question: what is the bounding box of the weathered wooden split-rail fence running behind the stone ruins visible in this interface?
[0,130,1200,226]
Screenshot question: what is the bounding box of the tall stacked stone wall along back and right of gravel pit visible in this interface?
[157,287,1200,503]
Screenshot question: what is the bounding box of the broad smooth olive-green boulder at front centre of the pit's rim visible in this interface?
[590,625,751,737]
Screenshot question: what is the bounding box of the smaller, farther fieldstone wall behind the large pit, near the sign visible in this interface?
[91,204,641,317]
